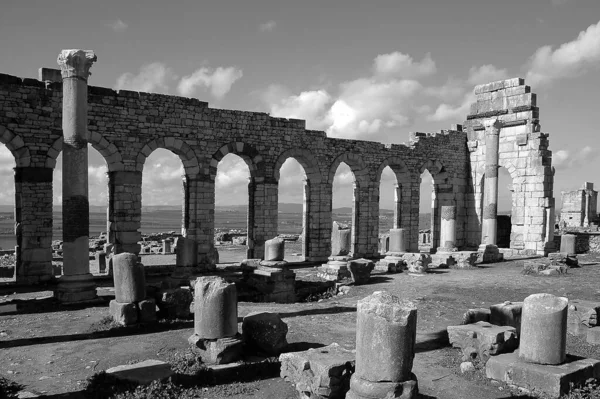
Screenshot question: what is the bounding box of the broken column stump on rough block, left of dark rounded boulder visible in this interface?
[188,276,242,364]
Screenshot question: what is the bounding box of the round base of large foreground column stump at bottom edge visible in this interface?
[346,373,419,399]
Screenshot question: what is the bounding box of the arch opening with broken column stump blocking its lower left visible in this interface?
[331,162,356,252]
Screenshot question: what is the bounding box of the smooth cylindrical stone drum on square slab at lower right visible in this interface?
[519,294,569,364]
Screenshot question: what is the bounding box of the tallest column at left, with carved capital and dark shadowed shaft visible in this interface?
[56,50,96,302]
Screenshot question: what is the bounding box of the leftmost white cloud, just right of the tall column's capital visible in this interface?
[115,62,177,94]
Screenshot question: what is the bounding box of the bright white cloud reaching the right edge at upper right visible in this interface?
[526,21,600,85]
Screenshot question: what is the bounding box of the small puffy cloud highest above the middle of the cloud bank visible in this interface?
[373,51,436,79]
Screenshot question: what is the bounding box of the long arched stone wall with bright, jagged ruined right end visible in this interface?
[0,58,554,282]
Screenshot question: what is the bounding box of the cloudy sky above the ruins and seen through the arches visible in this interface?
[0,0,600,210]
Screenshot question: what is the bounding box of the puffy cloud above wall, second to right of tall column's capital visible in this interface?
[177,67,243,99]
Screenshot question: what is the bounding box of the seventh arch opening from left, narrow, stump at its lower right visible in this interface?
[379,166,398,253]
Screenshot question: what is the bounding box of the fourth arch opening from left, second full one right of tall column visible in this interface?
[215,153,250,263]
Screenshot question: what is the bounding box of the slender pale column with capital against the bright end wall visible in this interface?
[482,119,502,245]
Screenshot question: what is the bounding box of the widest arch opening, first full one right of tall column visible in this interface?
[140,148,185,264]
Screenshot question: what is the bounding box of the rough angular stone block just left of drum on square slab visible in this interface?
[448,321,519,363]
